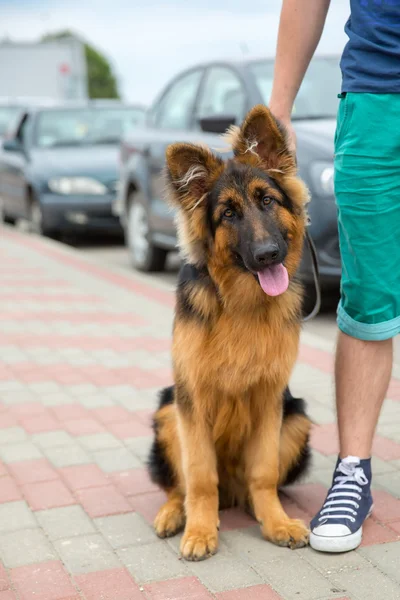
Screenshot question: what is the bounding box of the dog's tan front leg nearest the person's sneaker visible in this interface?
[246,390,308,548]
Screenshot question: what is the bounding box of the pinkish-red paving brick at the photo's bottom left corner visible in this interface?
[11,561,79,600]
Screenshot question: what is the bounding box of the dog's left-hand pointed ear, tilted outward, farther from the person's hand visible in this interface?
[166,143,224,210]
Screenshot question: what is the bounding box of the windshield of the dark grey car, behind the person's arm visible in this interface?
[249,57,341,120]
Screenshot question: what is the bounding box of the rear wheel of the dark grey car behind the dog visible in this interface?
[126,194,168,272]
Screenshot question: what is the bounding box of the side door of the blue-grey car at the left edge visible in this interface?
[0,113,29,218]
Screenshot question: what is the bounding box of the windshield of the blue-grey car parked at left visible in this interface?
[34,107,144,148]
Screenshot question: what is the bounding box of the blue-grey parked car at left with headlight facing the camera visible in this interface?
[0,101,145,236]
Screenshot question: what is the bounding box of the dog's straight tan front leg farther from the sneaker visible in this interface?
[179,407,218,560]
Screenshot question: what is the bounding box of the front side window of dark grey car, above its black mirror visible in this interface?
[196,67,246,123]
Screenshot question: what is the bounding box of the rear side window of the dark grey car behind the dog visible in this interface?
[154,69,203,130]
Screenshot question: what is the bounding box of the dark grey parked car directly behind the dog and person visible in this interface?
[114,56,340,286]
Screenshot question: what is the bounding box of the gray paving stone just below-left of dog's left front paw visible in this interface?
[117,540,190,583]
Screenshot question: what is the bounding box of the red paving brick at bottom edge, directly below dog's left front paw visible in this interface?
[143,577,212,600]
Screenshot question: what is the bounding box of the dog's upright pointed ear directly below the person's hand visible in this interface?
[231,104,296,175]
